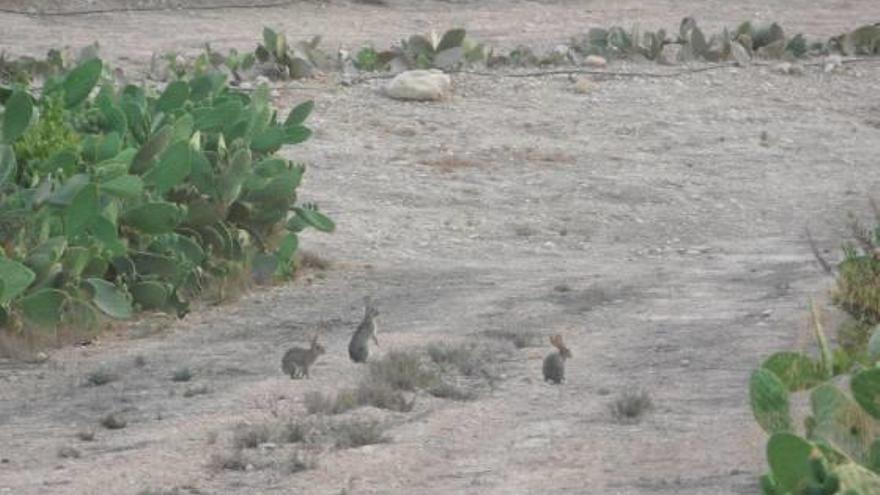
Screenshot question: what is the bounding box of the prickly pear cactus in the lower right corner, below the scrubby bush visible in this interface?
[749,300,880,495]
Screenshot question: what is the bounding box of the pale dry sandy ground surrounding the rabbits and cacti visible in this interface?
[0,0,880,495]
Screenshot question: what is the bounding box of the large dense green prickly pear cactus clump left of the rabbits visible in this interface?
[0,53,334,340]
